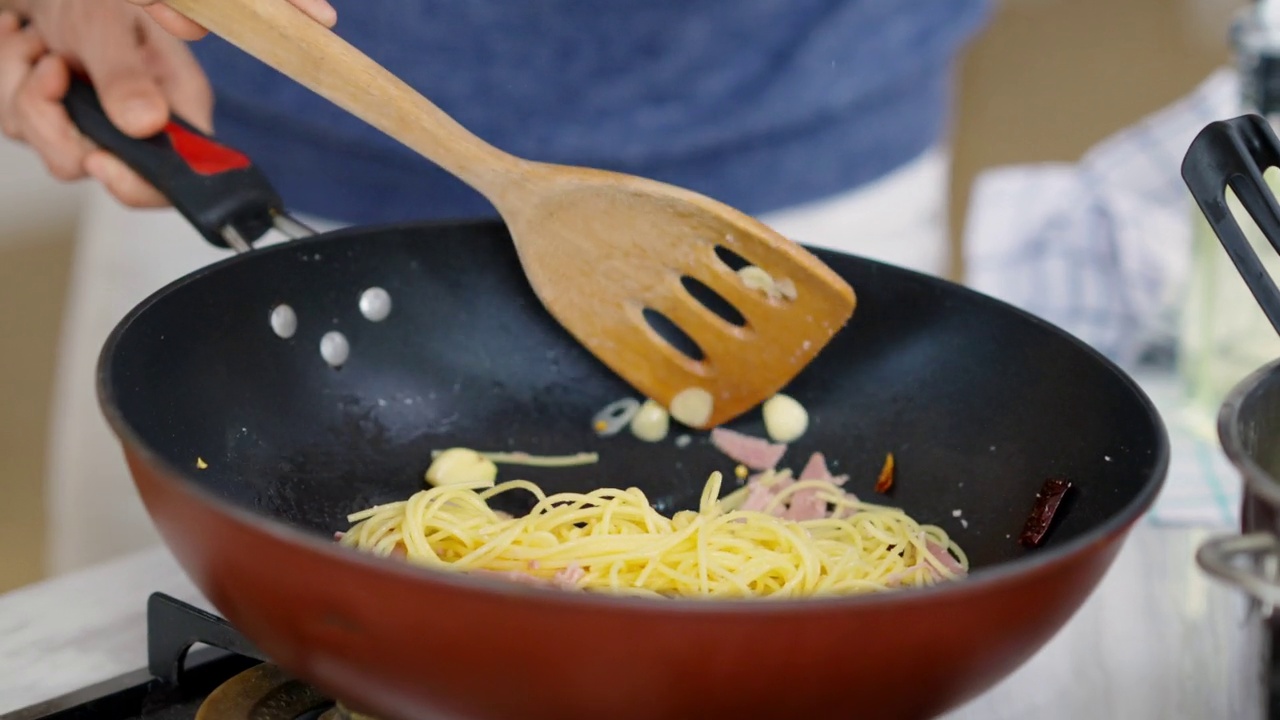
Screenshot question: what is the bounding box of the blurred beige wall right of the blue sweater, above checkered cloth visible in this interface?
[951,0,1245,278]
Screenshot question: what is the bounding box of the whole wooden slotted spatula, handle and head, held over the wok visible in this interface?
[166,0,855,428]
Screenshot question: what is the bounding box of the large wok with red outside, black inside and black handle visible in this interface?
[80,75,1169,720]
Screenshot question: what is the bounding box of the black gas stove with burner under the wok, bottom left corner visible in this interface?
[0,593,370,720]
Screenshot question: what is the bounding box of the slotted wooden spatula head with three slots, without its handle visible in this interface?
[499,165,855,428]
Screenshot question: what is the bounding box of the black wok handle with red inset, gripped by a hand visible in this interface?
[63,76,314,252]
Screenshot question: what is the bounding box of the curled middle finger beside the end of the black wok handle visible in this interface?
[17,55,91,181]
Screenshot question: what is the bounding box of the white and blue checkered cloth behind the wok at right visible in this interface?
[964,69,1240,525]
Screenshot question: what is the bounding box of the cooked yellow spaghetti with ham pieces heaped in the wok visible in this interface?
[338,456,968,598]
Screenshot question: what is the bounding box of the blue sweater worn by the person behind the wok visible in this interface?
[195,0,991,223]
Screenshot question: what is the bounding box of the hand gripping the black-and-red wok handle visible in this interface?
[0,0,214,208]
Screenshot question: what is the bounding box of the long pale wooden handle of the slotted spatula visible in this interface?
[165,0,525,200]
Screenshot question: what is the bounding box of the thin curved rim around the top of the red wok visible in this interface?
[96,219,1171,615]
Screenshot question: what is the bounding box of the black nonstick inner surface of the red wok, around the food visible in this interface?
[101,223,1165,568]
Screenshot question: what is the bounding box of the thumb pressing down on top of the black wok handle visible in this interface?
[79,10,169,137]
